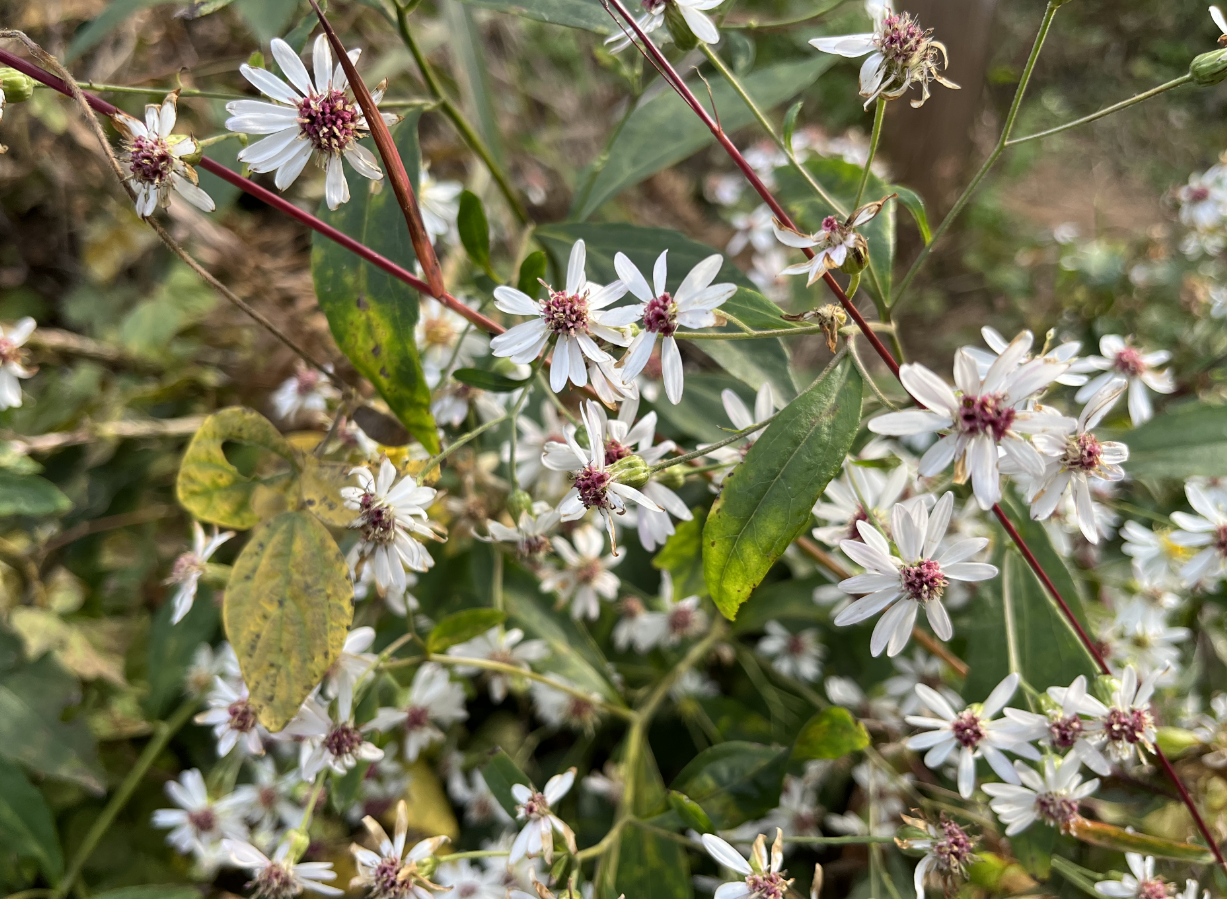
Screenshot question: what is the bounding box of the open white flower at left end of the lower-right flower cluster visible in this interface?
[906,673,1039,800]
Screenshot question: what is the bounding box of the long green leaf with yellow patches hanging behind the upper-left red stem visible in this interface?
[310,117,439,454]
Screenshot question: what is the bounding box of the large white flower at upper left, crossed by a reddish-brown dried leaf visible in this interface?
[219,34,400,210]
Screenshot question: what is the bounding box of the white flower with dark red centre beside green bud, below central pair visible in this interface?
[541,400,662,543]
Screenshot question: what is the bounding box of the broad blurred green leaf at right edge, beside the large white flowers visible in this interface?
[1104,402,1227,480]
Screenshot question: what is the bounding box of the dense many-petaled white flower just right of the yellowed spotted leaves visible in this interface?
[341,457,438,590]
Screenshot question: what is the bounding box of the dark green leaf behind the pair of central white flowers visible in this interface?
[535,223,795,399]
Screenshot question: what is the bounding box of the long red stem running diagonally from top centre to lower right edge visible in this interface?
[601,0,1227,870]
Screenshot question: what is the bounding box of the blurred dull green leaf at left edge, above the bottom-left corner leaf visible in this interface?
[0,655,104,794]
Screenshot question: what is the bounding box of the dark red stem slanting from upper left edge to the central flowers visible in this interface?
[0,42,506,334]
